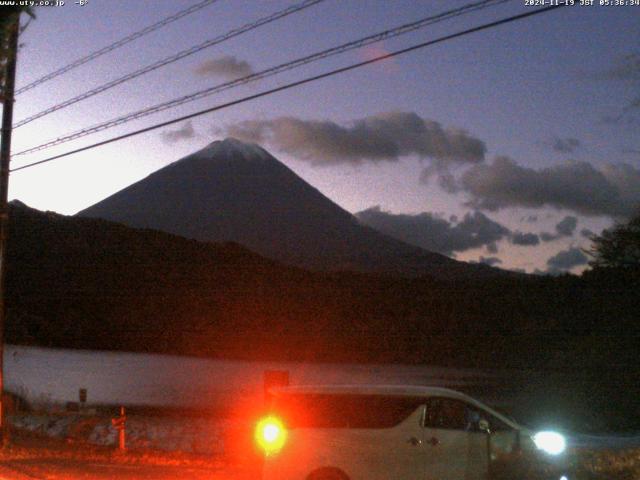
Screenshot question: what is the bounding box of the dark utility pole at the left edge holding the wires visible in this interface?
[0,13,20,446]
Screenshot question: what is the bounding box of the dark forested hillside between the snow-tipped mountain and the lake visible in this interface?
[6,205,640,369]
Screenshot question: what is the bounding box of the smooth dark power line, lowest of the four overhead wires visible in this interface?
[11,4,565,172]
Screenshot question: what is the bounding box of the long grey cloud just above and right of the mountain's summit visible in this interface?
[224,112,486,167]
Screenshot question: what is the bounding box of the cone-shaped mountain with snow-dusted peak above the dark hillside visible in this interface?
[78,139,498,278]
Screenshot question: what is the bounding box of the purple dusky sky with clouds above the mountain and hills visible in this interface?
[9,0,640,273]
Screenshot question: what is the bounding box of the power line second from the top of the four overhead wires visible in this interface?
[13,0,324,128]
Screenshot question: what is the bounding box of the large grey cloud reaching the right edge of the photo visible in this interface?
[456,157,640,217]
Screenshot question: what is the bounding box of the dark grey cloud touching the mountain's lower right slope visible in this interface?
[356,206,509,255]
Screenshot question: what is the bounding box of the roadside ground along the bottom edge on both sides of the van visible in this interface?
[0,431,640,480]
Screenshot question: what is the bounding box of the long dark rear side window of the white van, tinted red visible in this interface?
[272,394,424,428]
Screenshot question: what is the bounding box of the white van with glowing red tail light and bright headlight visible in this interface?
[255,385,568,480]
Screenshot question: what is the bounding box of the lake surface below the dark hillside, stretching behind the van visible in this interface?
[4,345,640,433]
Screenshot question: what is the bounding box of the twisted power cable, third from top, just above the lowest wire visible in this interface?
[13,0,511,156]
